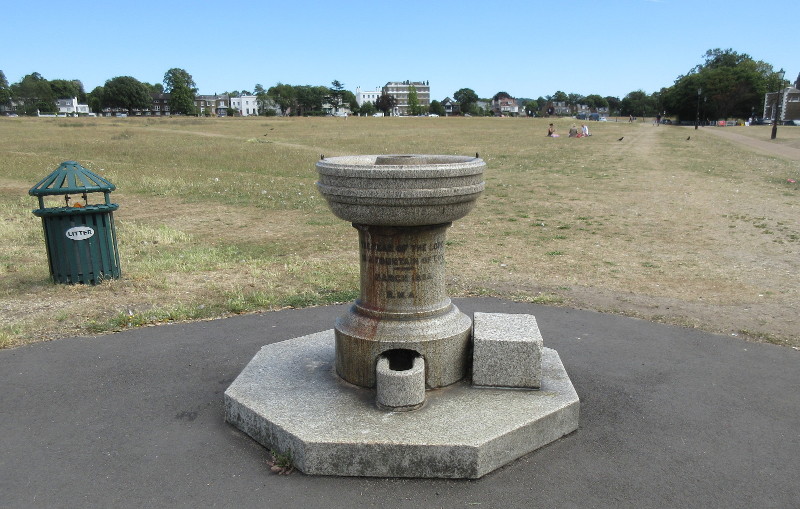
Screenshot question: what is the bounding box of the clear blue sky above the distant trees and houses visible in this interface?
[0,0,800,100]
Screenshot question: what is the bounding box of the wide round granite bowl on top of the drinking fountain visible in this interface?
[317,154,486,226]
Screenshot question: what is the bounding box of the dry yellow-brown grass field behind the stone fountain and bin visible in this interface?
[0,117,800,349]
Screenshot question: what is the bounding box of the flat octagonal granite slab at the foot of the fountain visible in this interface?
[225,330,580,479]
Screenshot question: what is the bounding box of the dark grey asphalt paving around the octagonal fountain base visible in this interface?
[0,299,800,509]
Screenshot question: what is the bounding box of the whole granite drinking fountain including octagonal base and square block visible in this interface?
[225,155,579,478]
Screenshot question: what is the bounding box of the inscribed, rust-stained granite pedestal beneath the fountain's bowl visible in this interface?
[336,223,472,388]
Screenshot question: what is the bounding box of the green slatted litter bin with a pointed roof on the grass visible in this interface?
[28,161,120,285]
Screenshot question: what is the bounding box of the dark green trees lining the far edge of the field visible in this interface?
[0,49,784,120]
